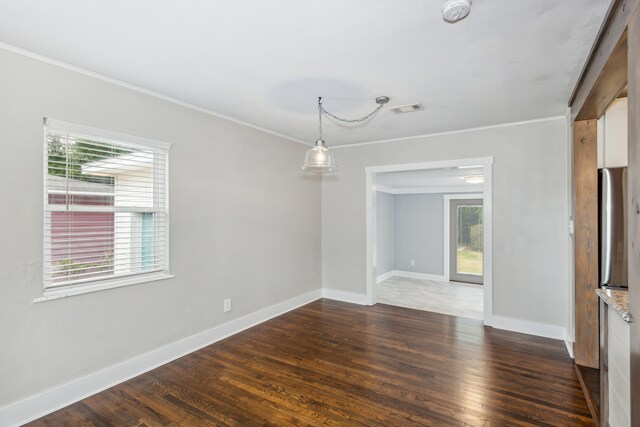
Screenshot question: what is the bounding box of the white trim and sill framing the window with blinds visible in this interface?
[38,118,175,303]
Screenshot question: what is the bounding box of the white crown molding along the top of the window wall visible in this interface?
[0,42,312,146]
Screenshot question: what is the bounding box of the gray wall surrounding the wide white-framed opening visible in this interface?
[322,119,569,326]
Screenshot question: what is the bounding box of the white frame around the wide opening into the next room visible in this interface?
[365,157,493,325]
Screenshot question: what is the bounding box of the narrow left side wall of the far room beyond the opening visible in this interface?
[376,191,395,275]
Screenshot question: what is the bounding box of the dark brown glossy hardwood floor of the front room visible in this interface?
[30,299,593,426]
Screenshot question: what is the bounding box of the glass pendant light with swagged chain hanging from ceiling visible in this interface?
[302,96,389,173]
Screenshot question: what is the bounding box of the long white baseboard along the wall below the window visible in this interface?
[0,289,320,426]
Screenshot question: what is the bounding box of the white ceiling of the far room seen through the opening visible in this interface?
[376,166,484,194]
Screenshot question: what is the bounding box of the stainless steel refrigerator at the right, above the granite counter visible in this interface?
[598,167,629,288]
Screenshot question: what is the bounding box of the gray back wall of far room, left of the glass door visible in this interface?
[394,194,444,275]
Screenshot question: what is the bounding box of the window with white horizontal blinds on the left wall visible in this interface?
[44,119,170,297]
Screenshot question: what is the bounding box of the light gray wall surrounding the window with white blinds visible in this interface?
[0,50,321,406]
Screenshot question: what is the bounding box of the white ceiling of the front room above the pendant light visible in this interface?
[0,0,611,145]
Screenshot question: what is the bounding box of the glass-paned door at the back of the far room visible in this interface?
[449,199,484,285]
